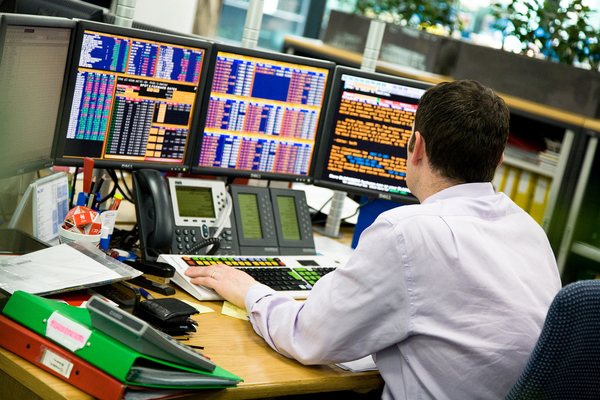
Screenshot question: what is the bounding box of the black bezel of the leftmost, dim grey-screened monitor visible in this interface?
[0,13,77,179]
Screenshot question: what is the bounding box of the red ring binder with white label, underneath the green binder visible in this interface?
[0,315,126,400]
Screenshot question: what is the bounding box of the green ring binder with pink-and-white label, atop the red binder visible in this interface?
[3,291,242,389]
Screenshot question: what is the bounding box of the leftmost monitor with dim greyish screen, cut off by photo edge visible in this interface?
[0,14,76,178]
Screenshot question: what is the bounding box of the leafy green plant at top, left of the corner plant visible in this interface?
[345,0,461,33]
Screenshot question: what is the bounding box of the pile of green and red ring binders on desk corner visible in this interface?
[0,291,242,400]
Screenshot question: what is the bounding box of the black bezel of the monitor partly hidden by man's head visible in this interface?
[313,66,434,204]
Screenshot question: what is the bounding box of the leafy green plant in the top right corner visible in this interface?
[493,0,600,70]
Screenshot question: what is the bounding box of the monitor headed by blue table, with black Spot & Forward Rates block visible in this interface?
[54,21,212,172]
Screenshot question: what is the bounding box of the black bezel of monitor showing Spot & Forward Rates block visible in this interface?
[53,20,213,172]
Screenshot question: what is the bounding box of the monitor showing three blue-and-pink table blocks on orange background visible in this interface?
[192,44,334,182]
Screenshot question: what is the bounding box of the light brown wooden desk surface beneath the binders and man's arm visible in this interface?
[0,291,383,400]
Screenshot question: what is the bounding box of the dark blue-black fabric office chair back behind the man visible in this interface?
[506,280,600,400]
